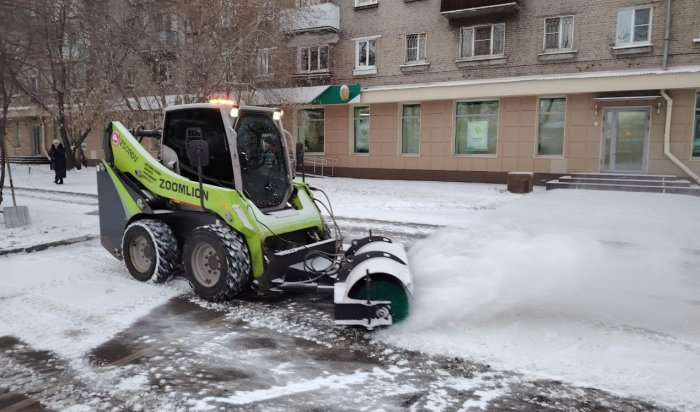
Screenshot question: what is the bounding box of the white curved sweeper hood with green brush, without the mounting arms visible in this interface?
[334,236,413,329]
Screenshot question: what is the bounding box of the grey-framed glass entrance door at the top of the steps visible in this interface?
[601,109,650,173]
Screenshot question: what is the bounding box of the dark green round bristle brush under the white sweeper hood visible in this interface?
[348,275,409,324]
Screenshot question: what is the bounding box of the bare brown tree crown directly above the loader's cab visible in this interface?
[108,0,295,129]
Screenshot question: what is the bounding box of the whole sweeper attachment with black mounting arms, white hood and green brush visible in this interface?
[260,235,413,329]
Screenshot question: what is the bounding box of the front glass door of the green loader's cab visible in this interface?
[236,112,291,209]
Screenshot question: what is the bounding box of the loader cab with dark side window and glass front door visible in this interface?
[161,104,292,211]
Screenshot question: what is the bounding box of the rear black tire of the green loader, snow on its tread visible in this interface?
[122,219,180,283]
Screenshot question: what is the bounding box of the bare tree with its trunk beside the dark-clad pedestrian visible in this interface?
[10,0,115,168]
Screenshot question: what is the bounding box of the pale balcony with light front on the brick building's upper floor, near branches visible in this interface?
[280,3,340,33]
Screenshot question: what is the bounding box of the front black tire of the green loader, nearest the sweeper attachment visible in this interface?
[183,225,250,302]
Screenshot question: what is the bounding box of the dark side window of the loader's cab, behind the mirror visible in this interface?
[163,108,234,188]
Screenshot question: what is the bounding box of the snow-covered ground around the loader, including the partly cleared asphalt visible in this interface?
[0,165,700,410]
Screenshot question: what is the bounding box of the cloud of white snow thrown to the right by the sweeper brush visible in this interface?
[378,191,700,409]
